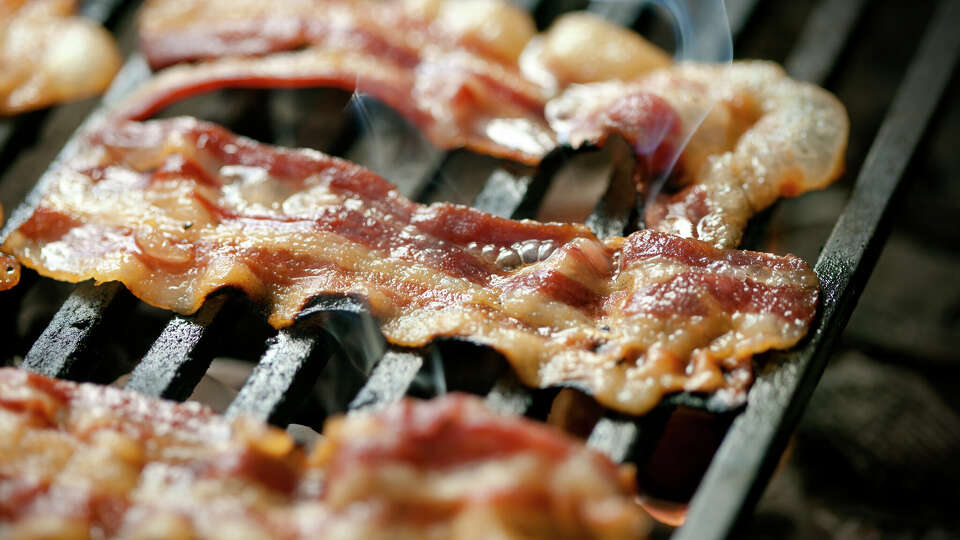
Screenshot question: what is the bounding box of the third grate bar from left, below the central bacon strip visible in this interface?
[226,323,333,426]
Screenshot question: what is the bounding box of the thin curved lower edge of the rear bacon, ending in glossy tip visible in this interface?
[114,47,557,164]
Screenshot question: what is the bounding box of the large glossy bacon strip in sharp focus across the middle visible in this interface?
[4,118,818,413]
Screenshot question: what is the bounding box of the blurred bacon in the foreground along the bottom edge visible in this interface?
[0,368,649,539]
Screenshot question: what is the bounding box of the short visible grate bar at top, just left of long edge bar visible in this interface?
[784,0,866,84]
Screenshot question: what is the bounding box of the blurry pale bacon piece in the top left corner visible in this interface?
[0,0,120,115]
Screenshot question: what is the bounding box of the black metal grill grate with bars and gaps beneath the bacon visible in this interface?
[0,0,960,539]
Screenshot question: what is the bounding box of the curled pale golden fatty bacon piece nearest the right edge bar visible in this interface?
[547,61,850,247]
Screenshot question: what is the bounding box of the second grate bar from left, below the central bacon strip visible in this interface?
[126,294,227,401]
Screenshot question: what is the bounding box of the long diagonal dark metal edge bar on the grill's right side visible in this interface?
[675,0,960,540]
